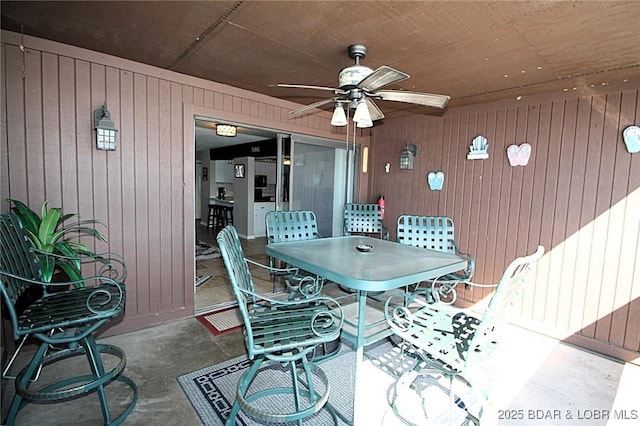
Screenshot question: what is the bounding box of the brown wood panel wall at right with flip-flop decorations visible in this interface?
[369,82,640,359]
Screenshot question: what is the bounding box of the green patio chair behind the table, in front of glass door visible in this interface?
[265,210,324,299]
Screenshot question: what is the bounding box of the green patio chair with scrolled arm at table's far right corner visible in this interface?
[396,215,475,304]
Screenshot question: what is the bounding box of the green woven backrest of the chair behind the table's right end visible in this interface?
[396,215,456,254]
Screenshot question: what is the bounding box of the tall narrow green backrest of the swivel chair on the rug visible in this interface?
[216,225,257,358]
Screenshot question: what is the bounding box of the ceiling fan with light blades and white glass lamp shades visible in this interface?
[277,44,450,127]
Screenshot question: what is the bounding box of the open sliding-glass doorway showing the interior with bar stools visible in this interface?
[194,117,354,314]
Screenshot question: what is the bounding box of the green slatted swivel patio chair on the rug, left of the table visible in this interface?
[217,226,343,425]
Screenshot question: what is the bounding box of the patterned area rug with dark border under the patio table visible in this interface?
[178,341,472,426]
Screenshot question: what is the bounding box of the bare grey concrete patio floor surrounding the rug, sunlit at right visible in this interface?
[2,231,640,426]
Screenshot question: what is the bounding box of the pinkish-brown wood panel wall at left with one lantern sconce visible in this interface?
[0,31,368,333]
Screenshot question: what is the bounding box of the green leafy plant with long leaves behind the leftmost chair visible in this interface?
[8,199,107,287]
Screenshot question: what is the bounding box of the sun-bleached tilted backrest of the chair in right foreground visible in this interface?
[467,246,544,363]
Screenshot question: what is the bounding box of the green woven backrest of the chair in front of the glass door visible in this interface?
[264,210,320,243]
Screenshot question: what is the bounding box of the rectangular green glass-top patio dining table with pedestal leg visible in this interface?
[266,236,466,423]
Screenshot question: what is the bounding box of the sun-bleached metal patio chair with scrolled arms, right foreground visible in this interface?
[385,246,544,424]
